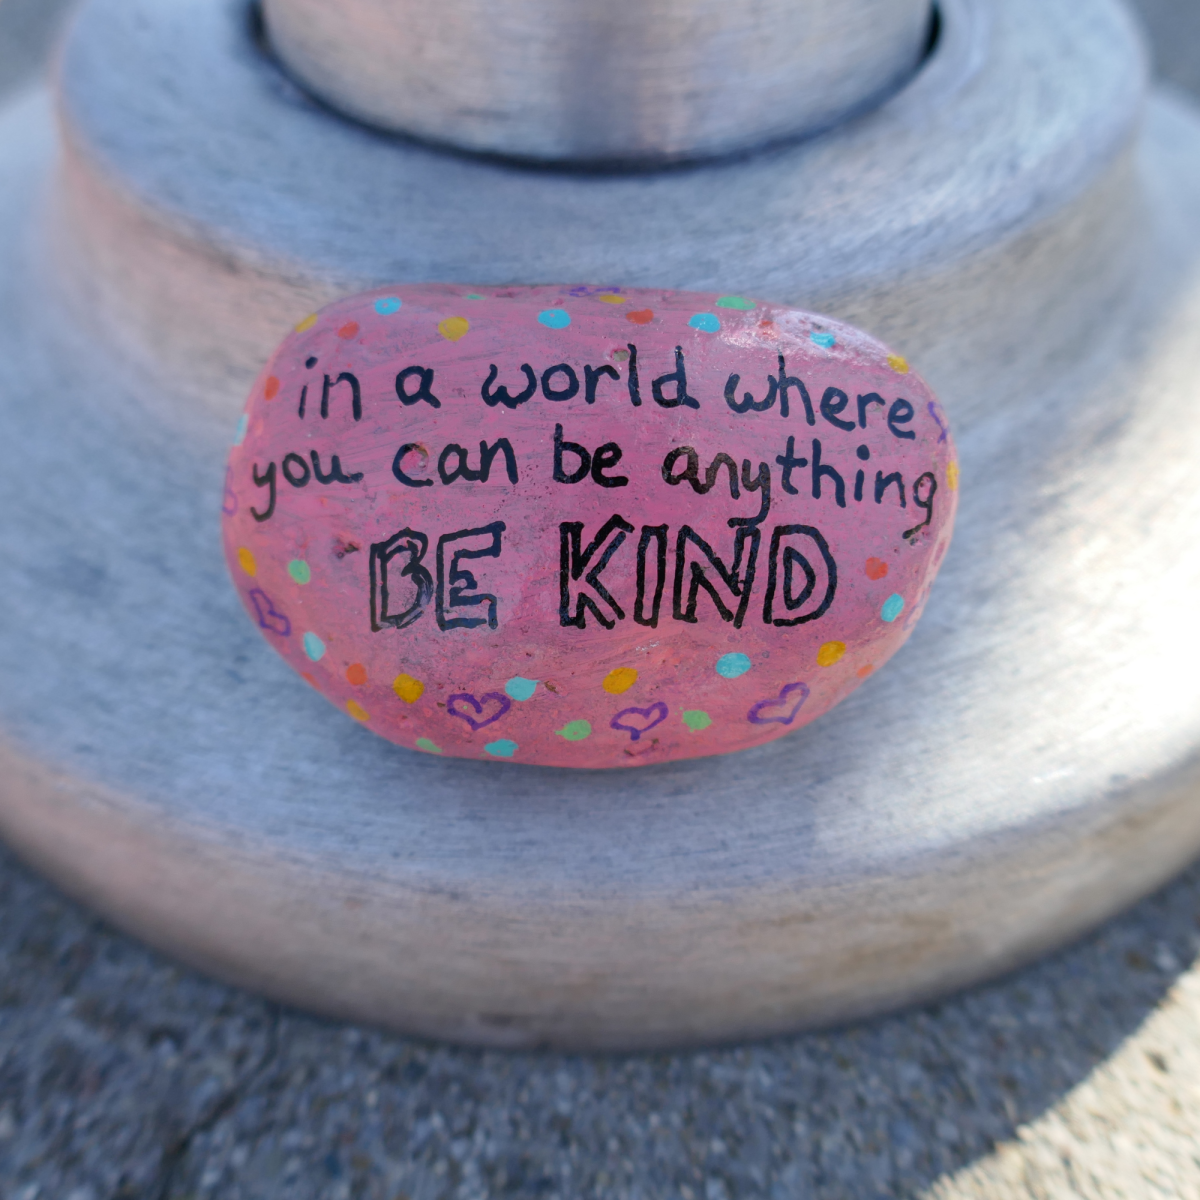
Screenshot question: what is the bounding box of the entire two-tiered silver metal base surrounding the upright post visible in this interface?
[0,0,1200,1046]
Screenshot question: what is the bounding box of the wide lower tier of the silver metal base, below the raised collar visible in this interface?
[0,79,1200,1048]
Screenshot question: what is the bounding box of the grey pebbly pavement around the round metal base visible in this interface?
[0,0,1200,1200]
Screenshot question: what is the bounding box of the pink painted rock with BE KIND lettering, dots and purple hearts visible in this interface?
[224,286,958,767]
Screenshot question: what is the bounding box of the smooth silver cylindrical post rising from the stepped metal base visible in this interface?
[264,0,932,161]
